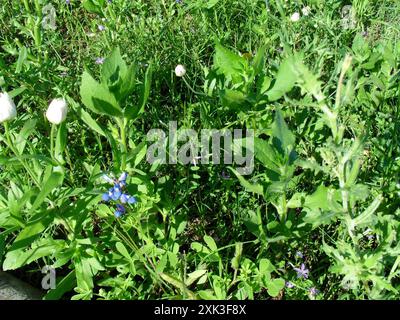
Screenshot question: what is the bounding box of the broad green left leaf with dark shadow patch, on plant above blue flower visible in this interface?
[80,71,122,117]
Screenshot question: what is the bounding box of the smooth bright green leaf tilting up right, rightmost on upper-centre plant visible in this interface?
[266,56,297,102]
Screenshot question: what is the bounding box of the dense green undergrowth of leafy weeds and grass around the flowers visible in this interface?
[0,0,400,299]
